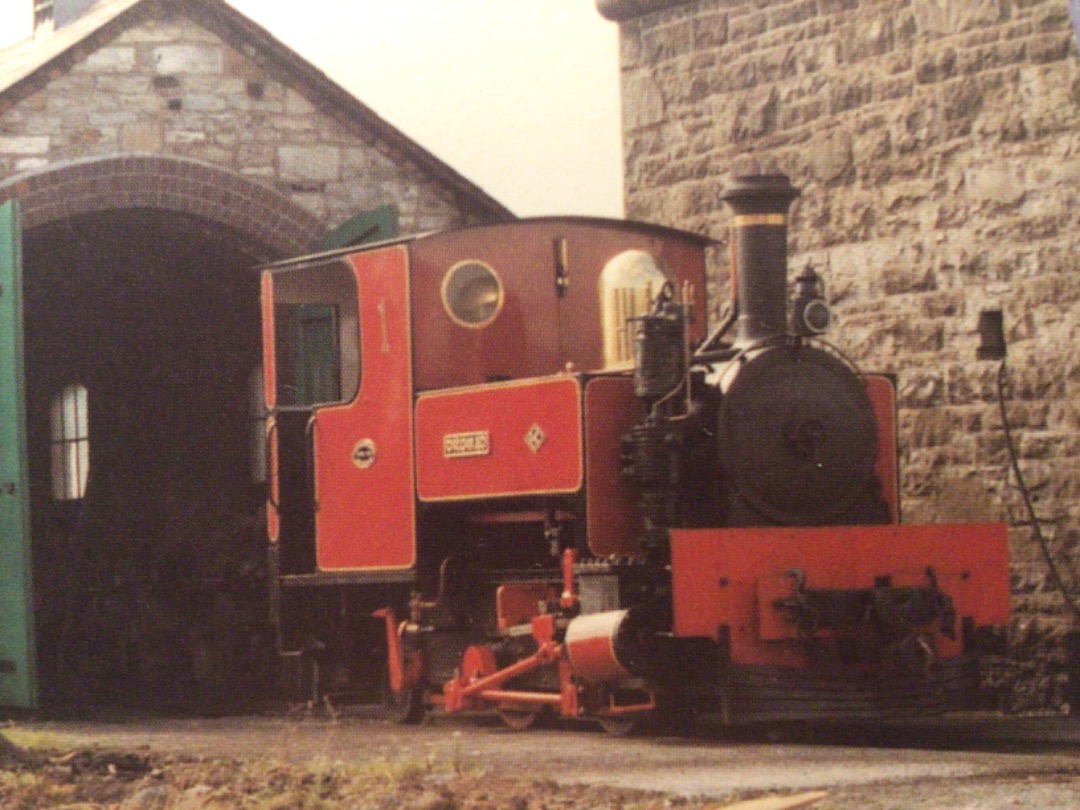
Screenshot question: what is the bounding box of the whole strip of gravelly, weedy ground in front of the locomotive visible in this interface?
[6,711,1080,810]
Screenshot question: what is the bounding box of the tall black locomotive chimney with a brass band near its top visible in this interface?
[720,174,799,349]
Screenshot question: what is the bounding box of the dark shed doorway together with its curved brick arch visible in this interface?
[0,157,322,707]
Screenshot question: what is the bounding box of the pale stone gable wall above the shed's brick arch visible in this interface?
[0,15,462,232]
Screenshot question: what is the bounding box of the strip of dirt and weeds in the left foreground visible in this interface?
[0,728,751,810]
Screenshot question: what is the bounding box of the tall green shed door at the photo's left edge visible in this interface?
[0,201,38,708]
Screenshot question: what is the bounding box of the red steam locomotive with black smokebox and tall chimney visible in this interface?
[262,175,1009,733]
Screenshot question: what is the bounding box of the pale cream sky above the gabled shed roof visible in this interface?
[0,0,623,217]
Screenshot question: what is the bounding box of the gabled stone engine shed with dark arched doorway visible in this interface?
[0,0,511,703]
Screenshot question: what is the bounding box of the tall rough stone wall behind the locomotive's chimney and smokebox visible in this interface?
[621,0,1080,708]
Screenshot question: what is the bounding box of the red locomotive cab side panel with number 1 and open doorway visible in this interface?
[264,246,416,576]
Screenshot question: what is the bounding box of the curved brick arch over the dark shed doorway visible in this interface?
[0,154,325,256]
